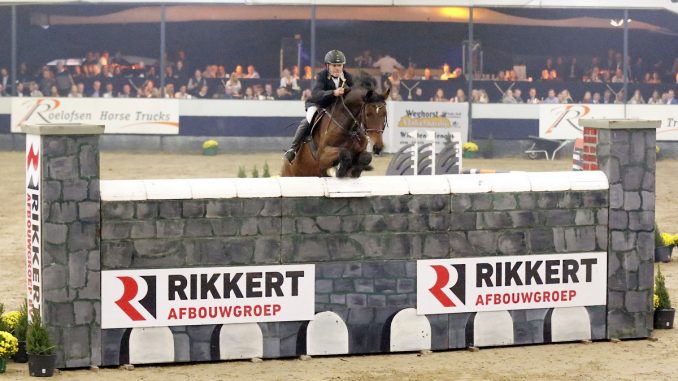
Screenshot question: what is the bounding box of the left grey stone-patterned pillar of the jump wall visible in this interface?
[41,135,101,368]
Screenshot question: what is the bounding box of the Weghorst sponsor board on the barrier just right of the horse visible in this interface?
[385,101,468,153]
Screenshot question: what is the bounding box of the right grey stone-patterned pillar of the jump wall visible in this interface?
[593,129,656,338]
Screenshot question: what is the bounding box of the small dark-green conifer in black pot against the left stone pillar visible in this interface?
[26,310,56,377]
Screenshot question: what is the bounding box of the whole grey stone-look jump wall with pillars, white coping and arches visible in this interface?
[28,121,658,367]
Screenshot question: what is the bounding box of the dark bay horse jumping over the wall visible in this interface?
[282,86,390,177]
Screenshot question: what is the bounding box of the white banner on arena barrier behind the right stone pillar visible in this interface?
[539,104,678,141]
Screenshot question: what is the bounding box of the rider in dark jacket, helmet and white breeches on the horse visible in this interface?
[285,50,353,163]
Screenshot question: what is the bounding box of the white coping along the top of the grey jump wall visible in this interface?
[101,171,609,201]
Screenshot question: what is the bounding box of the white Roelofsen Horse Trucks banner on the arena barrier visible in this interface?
[11,97,179,135]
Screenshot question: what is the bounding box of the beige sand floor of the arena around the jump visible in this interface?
[0,152,678,381]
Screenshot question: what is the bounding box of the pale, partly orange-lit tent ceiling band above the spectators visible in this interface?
[25,5,674,34]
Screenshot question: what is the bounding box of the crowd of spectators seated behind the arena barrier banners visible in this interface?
[0,49,678,104]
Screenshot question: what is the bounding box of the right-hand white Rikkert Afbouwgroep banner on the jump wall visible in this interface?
[417,252,607,315]
